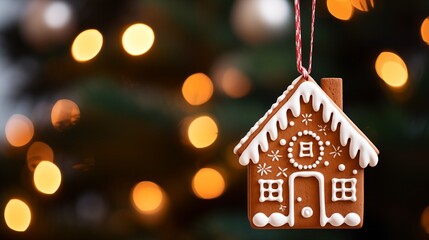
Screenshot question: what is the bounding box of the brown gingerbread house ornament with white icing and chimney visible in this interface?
[234,76,379,229]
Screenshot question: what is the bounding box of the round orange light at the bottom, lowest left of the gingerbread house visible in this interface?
[131,181,166,214]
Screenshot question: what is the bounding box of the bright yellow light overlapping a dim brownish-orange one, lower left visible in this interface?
[33,161,61,194]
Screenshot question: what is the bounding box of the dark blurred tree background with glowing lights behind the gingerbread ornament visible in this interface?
[0,0,429,240]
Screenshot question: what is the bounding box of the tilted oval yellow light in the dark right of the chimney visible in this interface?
[375,52,408,89]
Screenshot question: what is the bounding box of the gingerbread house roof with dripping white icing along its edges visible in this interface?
[234,76,378,168]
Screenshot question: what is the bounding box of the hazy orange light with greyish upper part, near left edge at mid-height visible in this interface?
[5,114,34,147]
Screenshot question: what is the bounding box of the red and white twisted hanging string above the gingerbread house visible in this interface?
[295,0,316,79]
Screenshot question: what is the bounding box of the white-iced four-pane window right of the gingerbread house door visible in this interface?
[332,178,357,202]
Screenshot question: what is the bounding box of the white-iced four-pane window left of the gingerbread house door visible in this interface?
[258,179,283,202]
